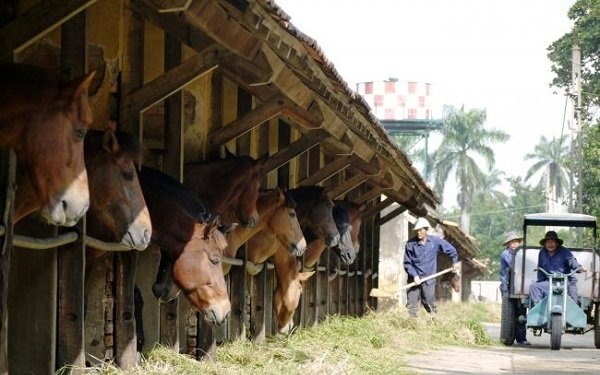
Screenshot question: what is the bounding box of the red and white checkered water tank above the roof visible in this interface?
[356,78,431,120]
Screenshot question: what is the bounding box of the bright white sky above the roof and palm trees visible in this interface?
[275,0,575,208]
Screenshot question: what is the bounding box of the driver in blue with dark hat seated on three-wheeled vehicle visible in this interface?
[529,230,585,306]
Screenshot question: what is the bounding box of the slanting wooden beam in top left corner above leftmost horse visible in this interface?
[0,0,97,60]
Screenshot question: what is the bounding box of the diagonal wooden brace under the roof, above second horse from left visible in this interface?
[125,46,223,119]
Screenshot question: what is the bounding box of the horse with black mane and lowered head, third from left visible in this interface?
[140,167,231,324]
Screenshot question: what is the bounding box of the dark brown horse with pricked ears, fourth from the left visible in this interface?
[184,155,268,228]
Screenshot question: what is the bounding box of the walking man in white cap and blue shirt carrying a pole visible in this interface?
[404,217,459,317]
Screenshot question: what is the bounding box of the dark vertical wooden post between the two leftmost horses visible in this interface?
[56,11,87,374]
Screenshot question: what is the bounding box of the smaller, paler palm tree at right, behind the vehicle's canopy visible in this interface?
[525,136,569,212]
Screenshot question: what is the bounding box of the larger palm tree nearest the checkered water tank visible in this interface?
[431,106,509,233]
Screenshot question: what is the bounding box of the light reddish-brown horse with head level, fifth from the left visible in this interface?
[223,188,306,273]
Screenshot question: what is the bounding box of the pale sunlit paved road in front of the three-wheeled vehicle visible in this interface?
[409,324,600,375]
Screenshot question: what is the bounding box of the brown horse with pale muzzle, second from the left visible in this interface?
[85,129,152,250]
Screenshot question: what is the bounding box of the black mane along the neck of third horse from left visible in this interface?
[140,166,212,223]
